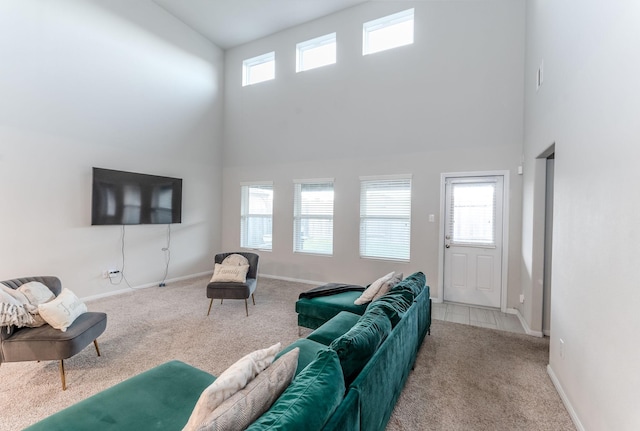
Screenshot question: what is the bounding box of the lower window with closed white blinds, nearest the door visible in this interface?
[360,175,411,261]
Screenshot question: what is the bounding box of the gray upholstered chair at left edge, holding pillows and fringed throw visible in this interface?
[0,276,107,390]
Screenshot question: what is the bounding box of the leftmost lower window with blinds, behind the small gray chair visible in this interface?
[240,183,273,250]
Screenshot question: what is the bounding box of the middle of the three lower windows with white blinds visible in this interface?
[293,180,333,254]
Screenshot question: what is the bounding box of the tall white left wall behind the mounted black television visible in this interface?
[0,0,223,297]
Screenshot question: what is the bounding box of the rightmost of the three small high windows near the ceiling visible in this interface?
[362,9,414,55]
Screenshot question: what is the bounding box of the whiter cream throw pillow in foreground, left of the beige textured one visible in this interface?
[183,343,282,431]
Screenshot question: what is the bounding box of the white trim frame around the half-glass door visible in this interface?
[438,170,510,313]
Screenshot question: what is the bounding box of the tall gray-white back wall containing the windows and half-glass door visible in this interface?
[222,0,525,307]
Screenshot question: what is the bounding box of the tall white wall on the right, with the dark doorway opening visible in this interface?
[523,0,640,431]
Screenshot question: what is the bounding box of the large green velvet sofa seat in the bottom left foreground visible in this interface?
[26,361,215,431]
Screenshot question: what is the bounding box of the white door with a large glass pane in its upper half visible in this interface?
[443,175,504,308]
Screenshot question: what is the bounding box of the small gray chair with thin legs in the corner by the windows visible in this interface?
[207,251,259,317]
